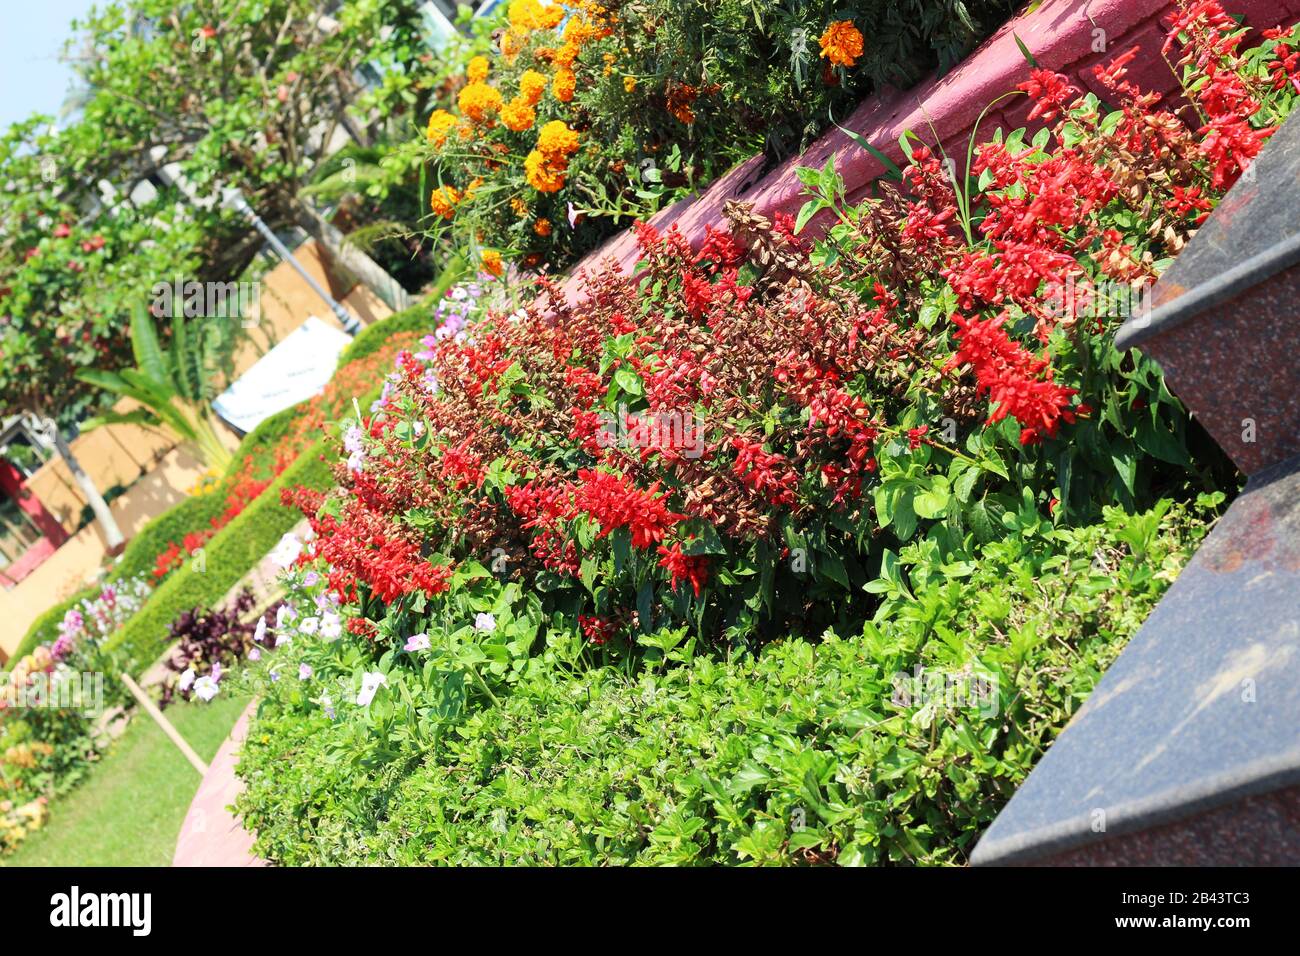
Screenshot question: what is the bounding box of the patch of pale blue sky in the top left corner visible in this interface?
[0,0,103,127]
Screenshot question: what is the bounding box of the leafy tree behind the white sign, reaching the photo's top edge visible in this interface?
[64,0,428,276]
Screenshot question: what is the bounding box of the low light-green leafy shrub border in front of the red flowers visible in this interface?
[239,501,1206,865]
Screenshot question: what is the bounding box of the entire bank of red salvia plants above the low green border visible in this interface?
[266,4,1297,719]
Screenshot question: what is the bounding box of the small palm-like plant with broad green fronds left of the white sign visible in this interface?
[77,303,239,472]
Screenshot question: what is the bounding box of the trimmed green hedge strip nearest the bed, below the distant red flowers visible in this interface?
[109,442,333,669]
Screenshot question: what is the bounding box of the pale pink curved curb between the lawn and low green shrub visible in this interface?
[172,701,267,866]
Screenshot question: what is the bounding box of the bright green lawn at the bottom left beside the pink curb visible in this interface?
[0,697,248,866]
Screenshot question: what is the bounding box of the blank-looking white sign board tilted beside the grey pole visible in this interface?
[212,316,351,432]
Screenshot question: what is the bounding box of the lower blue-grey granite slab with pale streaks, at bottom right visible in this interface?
[972,458,1300,865]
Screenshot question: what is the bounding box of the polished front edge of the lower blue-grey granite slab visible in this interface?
[971,752,1300,866]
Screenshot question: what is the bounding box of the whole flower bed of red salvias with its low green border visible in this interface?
[215,3,1300,864]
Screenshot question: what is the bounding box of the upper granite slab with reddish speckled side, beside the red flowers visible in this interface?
[1115,107,1300,475]
